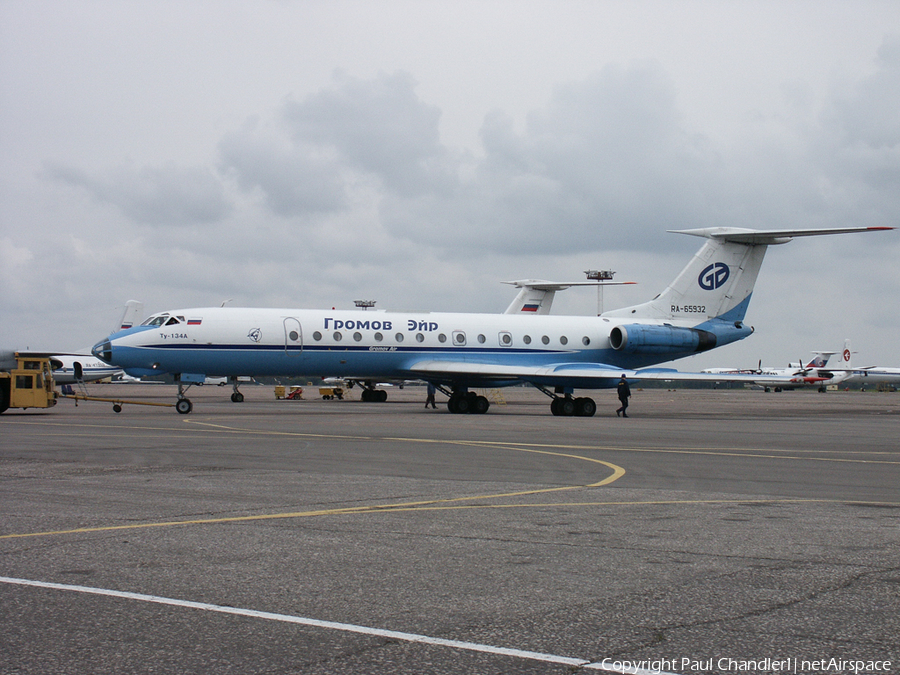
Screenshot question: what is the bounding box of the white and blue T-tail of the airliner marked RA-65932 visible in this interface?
[603,227,894,325]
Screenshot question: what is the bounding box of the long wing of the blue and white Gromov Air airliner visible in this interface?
[409,360,804,388]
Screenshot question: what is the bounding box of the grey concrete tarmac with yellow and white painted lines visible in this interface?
[0,385,900,675]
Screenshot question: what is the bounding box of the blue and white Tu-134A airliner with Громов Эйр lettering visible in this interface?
[92,227,894,416]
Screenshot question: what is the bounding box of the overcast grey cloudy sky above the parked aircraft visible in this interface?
[0,0,900,370]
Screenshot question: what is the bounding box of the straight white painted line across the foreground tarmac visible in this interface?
[0,577,676,675]
